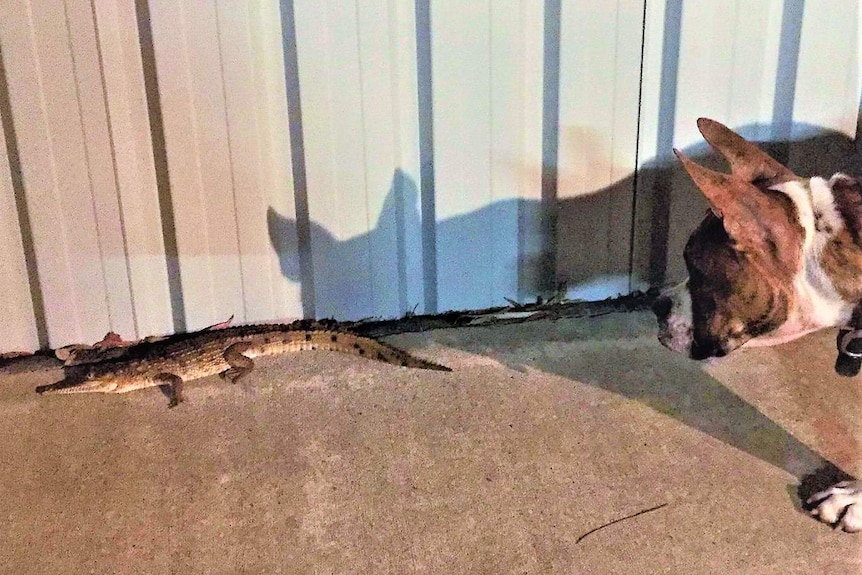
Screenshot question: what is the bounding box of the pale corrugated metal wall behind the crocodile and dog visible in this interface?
[0,0,860,351]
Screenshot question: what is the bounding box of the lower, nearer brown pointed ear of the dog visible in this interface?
[674,149,801,275]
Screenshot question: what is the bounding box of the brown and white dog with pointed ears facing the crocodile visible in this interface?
[653,118,862,532]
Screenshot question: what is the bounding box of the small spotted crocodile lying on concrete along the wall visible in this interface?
[36,324,452,407]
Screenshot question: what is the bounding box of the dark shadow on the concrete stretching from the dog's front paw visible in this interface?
[435,313,851,509]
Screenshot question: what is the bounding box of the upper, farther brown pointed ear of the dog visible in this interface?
[697,118,797,187]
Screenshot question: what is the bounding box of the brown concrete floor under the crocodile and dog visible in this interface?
[0,313,862,575]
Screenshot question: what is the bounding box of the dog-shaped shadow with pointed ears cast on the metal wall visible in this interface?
[267,124,862,319]
